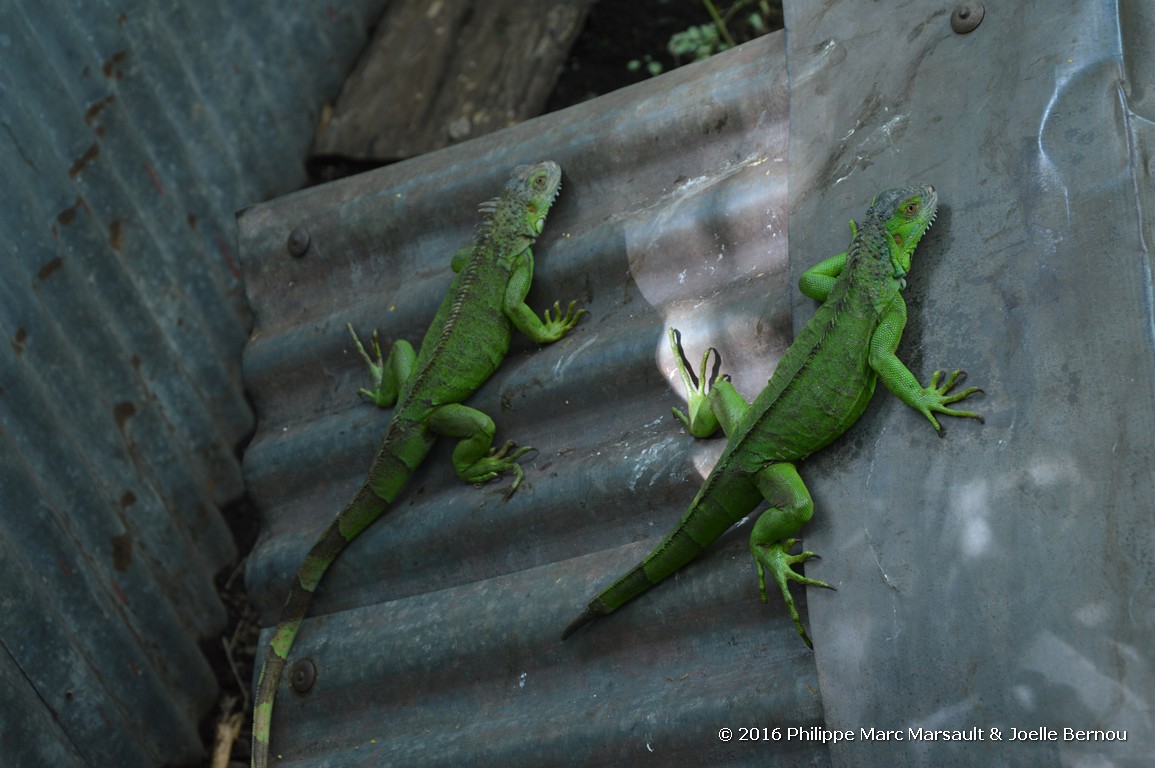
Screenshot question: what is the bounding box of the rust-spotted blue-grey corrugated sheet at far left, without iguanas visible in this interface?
[0,0,383,766]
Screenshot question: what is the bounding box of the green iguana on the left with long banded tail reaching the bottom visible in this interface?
[253,161,586,768]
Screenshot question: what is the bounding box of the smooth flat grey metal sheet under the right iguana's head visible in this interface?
[787,0,1155,766]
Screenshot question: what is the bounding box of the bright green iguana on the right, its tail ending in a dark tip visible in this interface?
[561,186,982,646]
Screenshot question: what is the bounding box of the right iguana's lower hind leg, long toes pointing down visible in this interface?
[750,462,834,648]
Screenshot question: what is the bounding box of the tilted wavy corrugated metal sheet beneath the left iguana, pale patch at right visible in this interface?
[239,35,827,766]
